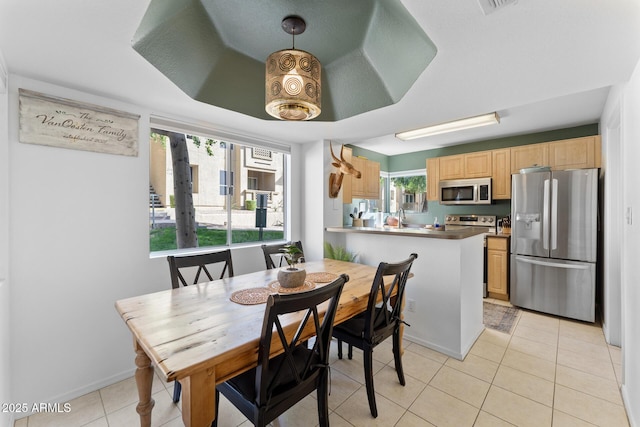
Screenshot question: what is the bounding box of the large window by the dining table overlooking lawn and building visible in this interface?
[149,129,289,252]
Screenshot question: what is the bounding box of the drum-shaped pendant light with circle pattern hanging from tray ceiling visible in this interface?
[265,16,322,120]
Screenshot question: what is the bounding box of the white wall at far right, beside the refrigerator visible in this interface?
[601,56,640,426]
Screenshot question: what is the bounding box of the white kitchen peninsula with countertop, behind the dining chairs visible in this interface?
[326,227,484,360]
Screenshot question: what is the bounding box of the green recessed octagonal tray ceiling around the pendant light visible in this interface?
[133,0,436,121]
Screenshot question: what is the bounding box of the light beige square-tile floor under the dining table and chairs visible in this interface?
[15,301,629,427]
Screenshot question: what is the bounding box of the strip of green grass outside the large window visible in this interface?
[149,227,284,252]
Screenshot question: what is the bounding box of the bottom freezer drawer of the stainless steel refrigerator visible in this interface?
[511,255,596,322]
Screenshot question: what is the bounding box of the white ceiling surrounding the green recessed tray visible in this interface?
[0,0,640,156]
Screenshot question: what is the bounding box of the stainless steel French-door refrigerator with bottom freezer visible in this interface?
[510,169,598,322]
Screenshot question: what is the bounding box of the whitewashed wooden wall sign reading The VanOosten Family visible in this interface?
[20,89,140,156]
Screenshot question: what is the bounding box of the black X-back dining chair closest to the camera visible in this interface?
[213,274,349,426]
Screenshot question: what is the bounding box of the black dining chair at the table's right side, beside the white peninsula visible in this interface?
[333,253,418,418]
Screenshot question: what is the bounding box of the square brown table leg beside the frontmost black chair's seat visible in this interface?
[179,368,217,427]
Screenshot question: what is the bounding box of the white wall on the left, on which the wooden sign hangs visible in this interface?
[5,75,302,416]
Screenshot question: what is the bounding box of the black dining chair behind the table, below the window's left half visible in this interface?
[167,249,233,403]
